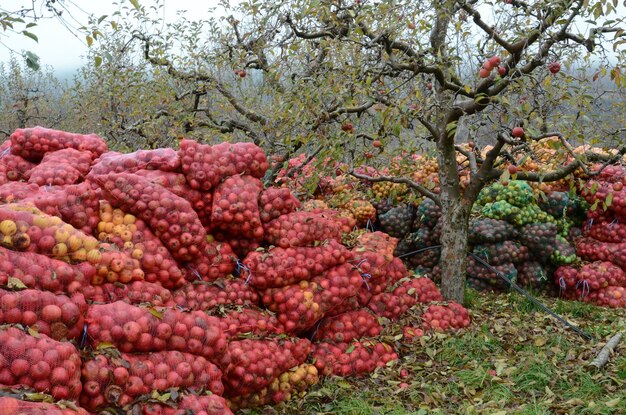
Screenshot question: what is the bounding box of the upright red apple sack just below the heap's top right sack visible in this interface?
[211,175,263,240]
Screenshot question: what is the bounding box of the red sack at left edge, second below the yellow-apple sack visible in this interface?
[0,289,87,340]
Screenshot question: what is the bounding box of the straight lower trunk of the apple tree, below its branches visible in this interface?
[439,203,470,304]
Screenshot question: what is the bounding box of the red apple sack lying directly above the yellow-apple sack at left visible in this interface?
[23,182,100,235]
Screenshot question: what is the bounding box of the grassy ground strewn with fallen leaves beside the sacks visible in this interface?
[247,291,626,415]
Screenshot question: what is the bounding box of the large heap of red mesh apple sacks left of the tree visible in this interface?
[0,127,468,415]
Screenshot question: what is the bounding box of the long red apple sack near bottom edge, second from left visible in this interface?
[80,351,224,411]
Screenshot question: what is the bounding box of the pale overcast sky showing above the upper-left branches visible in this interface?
[0,0,222,73]
